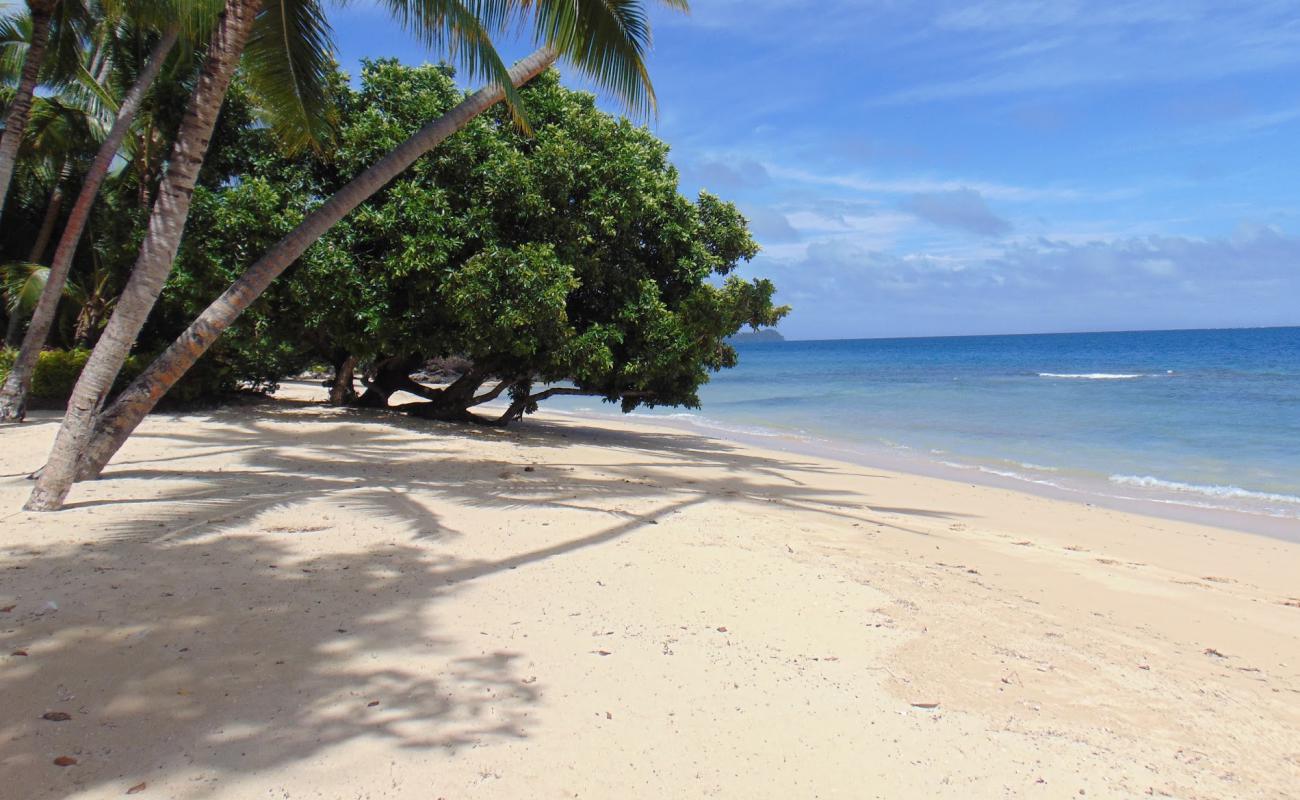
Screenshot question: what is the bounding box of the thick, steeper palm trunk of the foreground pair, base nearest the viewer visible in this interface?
[25,0,261,511]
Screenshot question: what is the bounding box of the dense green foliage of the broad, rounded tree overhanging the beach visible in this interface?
[164,61,785,418]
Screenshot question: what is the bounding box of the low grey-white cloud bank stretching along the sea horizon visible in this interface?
[751,226,1300,336]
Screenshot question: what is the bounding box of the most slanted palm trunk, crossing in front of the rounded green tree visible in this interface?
[71,47,558,489]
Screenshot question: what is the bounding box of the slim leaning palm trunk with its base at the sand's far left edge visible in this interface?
[0,27,179,421]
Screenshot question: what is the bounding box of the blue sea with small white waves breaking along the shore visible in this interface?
[556,328,1300,532]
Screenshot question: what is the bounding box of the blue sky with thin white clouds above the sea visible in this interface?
[330,0,1300,338]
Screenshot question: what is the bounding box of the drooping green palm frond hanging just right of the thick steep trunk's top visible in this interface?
[243,0,334,148]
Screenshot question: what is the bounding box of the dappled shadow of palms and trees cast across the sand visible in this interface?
[0,405,956,797]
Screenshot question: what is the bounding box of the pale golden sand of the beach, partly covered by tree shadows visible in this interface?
[0,385,1300,800]
